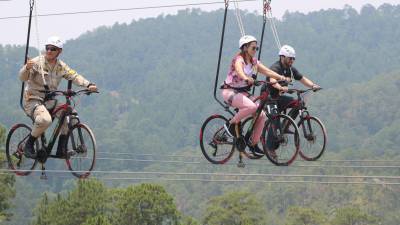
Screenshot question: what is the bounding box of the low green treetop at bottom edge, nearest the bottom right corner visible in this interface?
[331,207,380,225]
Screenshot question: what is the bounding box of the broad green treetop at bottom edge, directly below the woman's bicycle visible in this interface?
[203,192,267,225]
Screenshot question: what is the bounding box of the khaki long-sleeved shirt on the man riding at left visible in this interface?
[19,55,90,101]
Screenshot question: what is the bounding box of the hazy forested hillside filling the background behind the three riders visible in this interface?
[0,5,400,224]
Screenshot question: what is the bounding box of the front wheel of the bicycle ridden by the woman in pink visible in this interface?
[262,114,299,166]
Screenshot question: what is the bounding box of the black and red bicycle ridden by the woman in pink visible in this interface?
[200,81,299,167]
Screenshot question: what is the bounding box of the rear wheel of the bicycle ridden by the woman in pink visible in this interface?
[200,115,235,164]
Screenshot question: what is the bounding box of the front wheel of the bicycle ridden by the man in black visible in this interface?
[298,116,327,161]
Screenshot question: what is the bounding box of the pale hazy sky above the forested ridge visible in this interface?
[0,0,400,46]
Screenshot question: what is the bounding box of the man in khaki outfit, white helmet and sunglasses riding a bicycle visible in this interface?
[19,36,97,158]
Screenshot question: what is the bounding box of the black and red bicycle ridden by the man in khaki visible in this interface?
[6,89,97,178]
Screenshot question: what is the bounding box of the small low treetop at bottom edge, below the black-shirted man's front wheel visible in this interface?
[285,207,326,225]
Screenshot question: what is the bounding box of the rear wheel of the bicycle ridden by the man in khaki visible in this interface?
[6,124,39,176]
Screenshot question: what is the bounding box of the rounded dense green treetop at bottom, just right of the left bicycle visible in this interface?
[114,184,179,225]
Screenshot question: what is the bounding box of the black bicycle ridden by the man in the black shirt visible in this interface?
[288,88,327,161]
